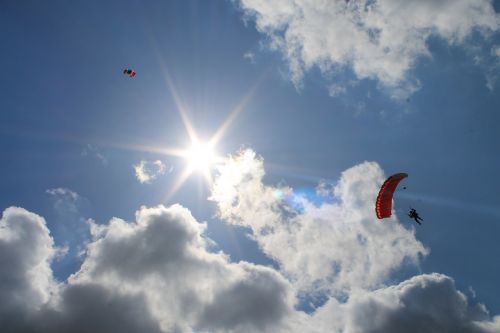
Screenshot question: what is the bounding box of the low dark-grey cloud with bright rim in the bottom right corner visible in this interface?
[310,273,500,333]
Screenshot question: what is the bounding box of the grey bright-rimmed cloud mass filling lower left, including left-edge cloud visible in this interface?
[0,205,293,332]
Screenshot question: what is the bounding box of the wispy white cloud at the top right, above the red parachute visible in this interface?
[239,0,500,98]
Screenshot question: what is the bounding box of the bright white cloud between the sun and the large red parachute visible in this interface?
[211,150,428,294]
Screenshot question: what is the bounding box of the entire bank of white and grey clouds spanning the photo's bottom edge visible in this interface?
[0,150,500,333]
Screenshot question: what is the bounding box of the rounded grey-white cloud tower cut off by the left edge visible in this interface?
[0,207,55,326]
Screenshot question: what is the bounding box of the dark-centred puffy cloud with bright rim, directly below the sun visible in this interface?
[72,205,292,332]
